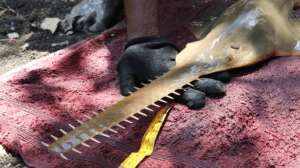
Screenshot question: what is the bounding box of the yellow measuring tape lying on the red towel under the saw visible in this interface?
[119,103,177,168]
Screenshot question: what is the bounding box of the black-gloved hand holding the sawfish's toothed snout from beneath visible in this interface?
[117,36,230,109]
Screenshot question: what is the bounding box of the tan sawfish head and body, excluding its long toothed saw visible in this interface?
[175,0,299,74]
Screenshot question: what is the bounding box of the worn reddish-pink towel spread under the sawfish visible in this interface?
[0,0,300,168]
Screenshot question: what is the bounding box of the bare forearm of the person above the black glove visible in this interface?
[123,0,159,41]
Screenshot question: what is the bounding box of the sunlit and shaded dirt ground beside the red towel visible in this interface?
[0,0,116,168]
